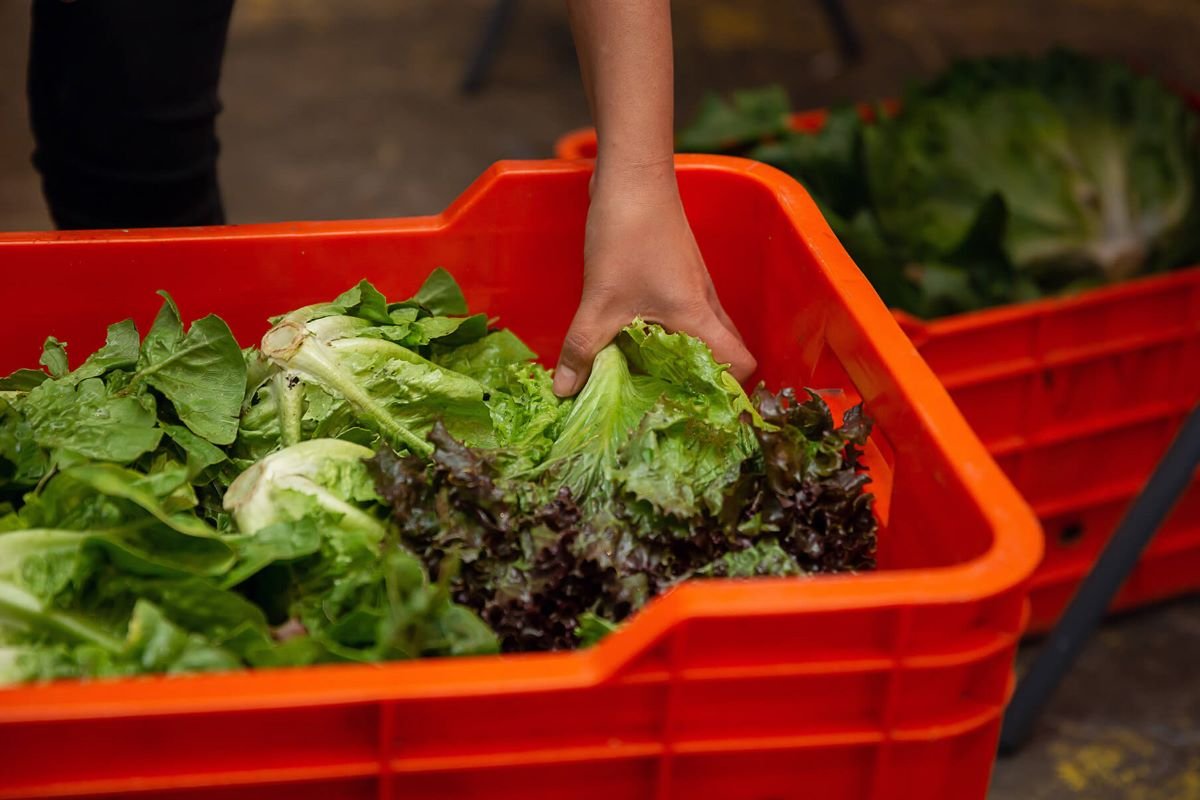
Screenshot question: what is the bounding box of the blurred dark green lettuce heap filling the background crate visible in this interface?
[678,50,1200,318]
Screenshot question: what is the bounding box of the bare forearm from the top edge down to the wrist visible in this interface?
[568,0,674,191]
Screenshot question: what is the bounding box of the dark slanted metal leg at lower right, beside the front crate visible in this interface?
[1000,405,1200,754]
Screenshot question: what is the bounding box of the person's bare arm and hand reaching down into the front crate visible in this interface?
[554,0,755,397]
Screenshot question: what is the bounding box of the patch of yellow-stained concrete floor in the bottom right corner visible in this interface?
[1003,597,1200,800]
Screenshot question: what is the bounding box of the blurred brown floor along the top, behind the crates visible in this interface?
[0,0,1200,230]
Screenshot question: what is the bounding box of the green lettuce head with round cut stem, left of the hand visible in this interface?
[244,269,496,458]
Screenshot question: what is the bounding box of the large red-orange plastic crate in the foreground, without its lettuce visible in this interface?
[0,157,1042,800]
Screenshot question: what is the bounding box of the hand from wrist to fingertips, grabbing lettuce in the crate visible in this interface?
[554,162,756,397]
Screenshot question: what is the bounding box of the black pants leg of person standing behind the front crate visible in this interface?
[29,0,233,228]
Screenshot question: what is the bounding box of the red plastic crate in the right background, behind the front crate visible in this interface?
[556,115,1200,632]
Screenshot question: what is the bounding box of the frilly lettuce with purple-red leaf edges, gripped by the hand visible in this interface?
[373,367,876,650]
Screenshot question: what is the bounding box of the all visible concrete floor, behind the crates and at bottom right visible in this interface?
[0,0,1200,800]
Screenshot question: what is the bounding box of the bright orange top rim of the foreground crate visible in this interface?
[0,155,1043,724]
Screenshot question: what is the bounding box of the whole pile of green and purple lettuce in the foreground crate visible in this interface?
[0,270,876,682]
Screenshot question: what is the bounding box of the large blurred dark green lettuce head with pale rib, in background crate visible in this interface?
[864,53,1198,303]
